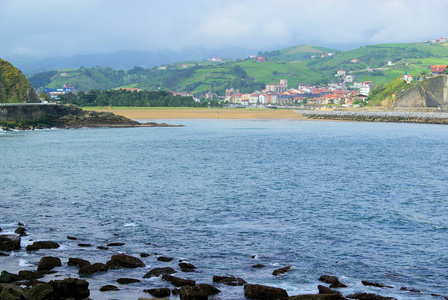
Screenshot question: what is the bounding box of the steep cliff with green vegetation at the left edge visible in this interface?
[0,59,39,103]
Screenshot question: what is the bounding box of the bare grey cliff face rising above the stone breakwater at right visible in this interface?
[394,75,448,110]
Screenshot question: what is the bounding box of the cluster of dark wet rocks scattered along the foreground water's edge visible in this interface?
[0,224,448,300]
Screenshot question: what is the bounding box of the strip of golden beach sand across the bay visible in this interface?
[89,108,309,120]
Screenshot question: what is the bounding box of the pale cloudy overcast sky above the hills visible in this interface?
[0,0,448,58]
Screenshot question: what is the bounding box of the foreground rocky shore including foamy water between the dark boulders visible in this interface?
[0,223,448,300]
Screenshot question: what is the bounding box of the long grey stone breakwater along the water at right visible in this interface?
[298,111,448,124]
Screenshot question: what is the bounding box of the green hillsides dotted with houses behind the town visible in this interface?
[29,42,448,95]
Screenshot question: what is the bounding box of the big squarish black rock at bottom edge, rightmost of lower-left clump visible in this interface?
[49,278,90,300]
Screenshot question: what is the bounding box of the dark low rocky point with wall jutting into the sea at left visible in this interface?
[0,105,183,131]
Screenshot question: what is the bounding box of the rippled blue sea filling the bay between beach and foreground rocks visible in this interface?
[0,120,448,299]
